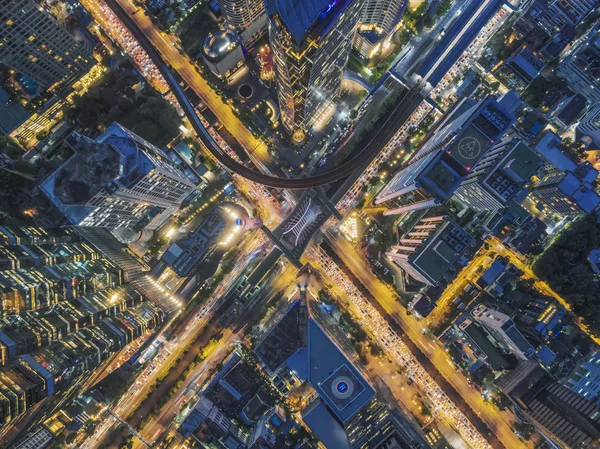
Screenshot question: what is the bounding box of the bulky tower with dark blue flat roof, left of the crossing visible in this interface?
[40,123,194,230]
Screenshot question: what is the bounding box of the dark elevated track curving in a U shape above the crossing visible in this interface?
[106,0,422,189]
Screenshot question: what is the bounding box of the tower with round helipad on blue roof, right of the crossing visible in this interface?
[374,98,514,215]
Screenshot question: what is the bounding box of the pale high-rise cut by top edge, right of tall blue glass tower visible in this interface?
[354,0,408,58]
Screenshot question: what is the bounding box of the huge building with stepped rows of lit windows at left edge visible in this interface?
[0,226,164,426]
